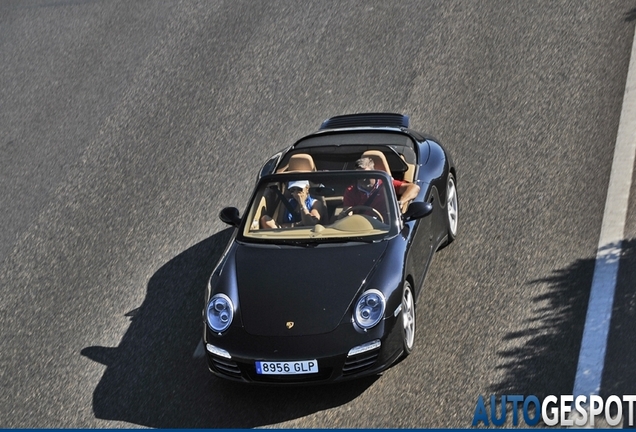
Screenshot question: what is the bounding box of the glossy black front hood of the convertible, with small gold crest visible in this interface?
[235,242,387,336]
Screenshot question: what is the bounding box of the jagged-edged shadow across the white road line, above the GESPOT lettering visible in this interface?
[490,239,636,422]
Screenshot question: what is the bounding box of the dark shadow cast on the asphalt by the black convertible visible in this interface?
[81,229,376,429]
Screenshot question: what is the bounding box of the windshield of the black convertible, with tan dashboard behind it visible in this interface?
[240,170,398,243]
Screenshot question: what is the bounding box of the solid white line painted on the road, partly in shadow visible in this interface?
[573,31,636,397]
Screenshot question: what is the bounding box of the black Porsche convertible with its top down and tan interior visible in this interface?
[203,113,458,384]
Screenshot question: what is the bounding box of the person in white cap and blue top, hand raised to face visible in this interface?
[260,180,322,229]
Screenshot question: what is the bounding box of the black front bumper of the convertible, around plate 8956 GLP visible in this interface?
[204,316,403,384]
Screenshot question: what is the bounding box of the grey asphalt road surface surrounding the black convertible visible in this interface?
[0,0,636,428]
